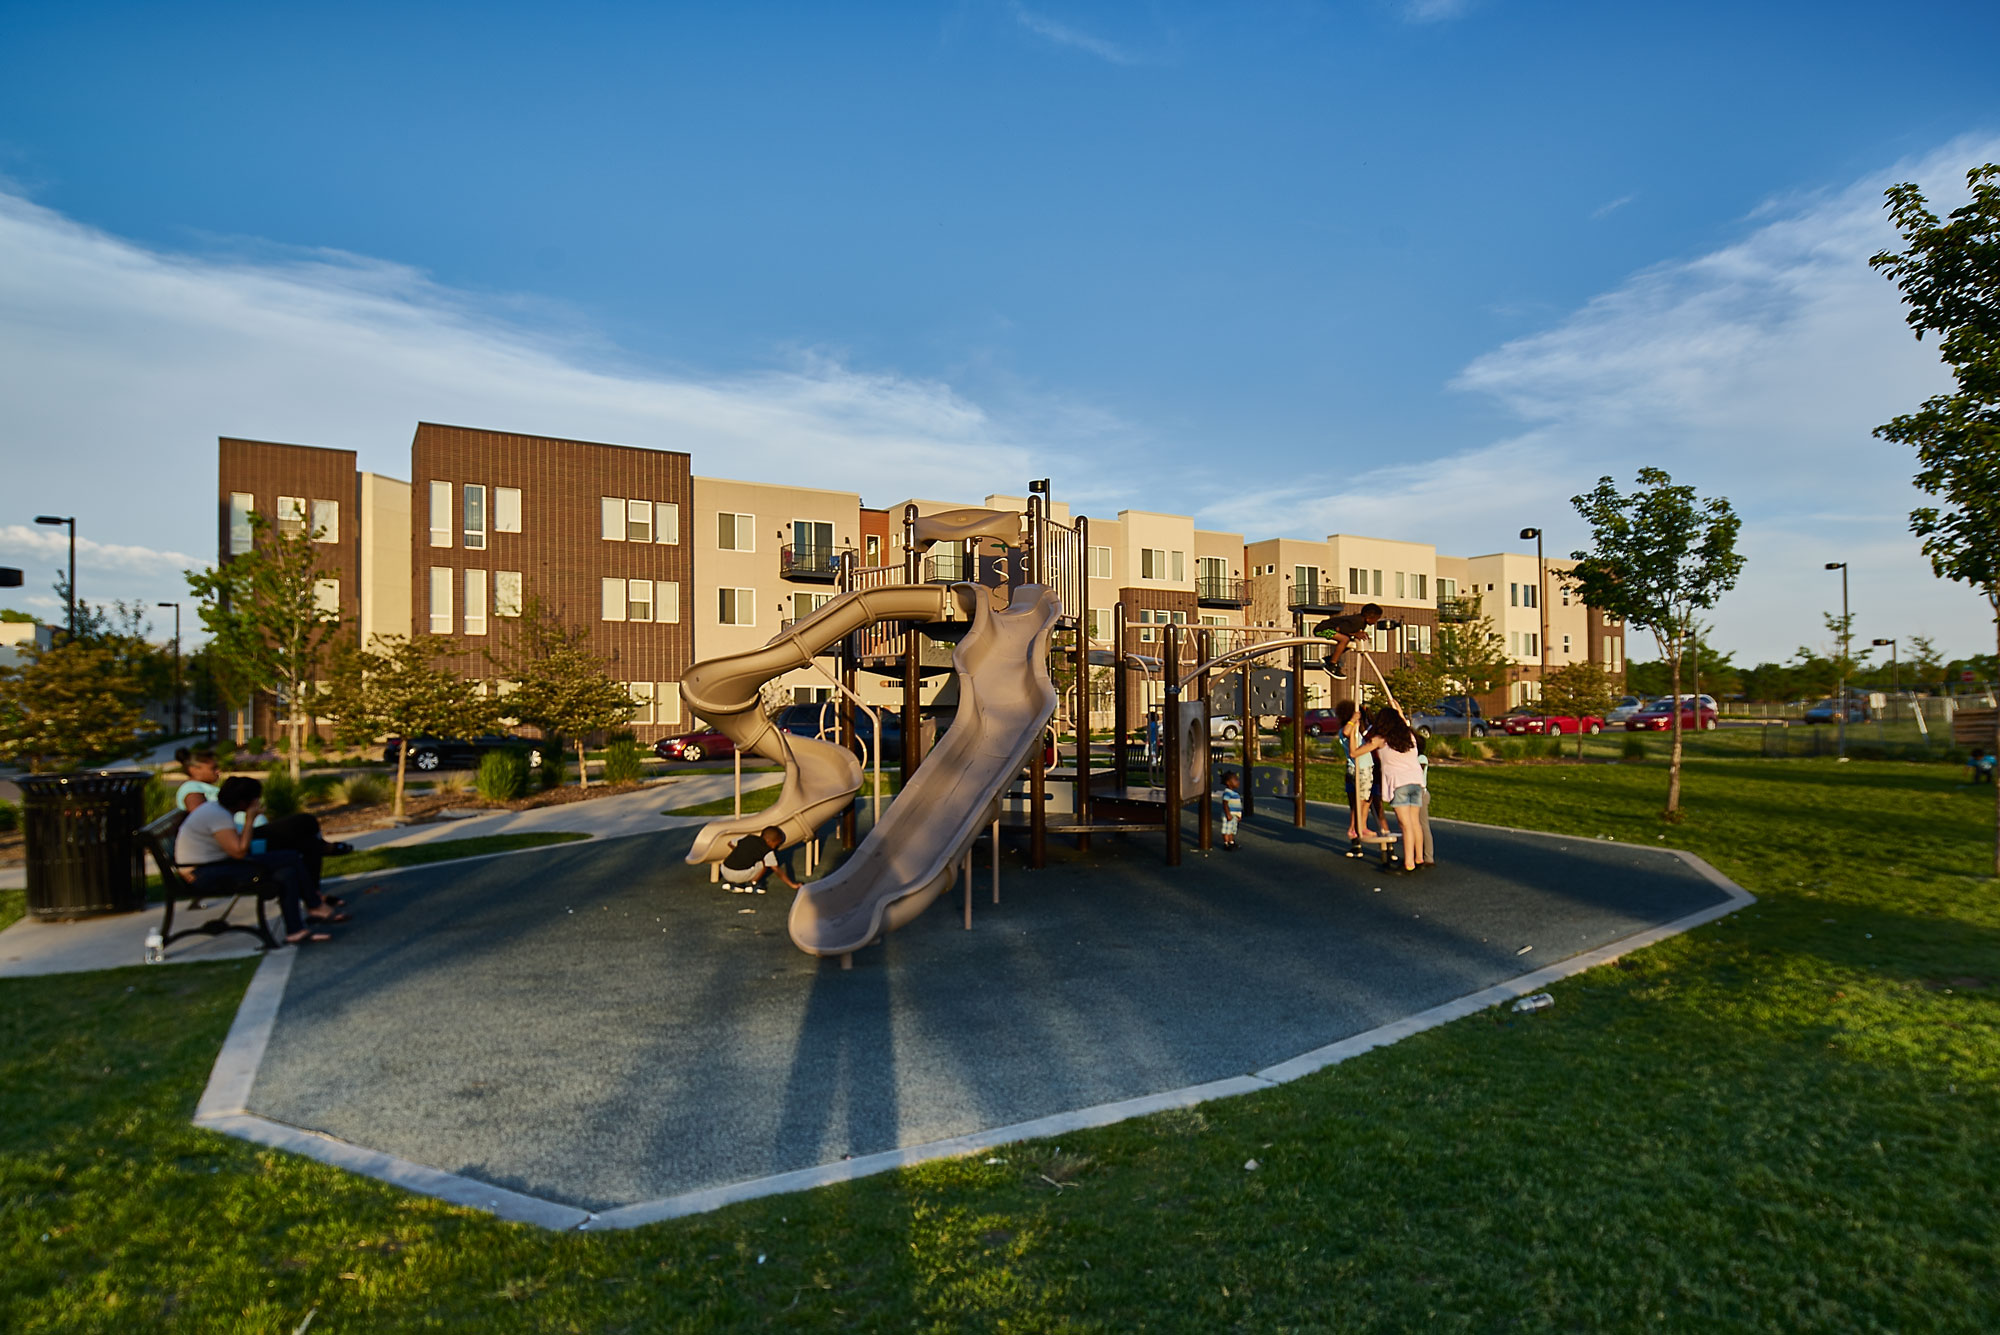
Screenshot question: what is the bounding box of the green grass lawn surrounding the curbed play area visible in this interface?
[0,761,2000,1333]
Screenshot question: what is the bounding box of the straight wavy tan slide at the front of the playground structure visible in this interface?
[790,584,1060,955]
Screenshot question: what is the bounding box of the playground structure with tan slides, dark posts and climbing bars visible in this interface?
[680,494,1338,965]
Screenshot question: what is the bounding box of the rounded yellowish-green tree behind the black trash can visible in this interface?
[0,640,146,773]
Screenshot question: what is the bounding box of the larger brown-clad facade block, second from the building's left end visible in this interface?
[410,422,694,741]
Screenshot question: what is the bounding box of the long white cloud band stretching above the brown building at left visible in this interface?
[0,194,1160,631]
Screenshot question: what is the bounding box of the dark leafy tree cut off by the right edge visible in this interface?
[1868,162,2000,875]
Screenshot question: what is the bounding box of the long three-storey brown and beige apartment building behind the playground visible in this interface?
[218,422,1624,741]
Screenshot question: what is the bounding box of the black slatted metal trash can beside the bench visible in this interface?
[16,769,152,919]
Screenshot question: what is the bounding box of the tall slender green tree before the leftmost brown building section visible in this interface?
[186,512,342,779]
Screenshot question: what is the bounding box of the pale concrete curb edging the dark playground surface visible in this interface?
[194,819,1756,1231]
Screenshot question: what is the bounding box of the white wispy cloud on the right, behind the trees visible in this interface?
[1204,140,2000,660]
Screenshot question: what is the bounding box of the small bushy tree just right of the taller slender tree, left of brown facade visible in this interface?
[322,636,500,817]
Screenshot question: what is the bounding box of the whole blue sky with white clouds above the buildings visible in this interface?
[0,0,2000,658]
